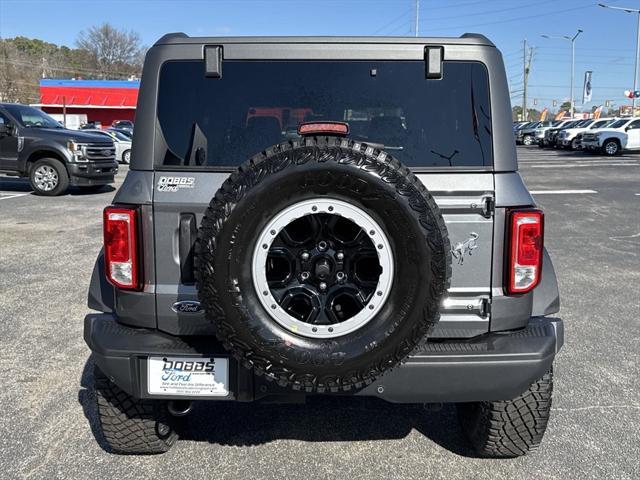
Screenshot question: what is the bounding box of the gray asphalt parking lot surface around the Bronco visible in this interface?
[0,147,640,480]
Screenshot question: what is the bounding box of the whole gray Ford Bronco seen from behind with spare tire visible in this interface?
[84,34,563,457]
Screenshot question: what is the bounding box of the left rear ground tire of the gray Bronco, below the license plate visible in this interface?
[93,367,178,454]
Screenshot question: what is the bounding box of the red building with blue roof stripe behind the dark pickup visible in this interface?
[35,79,140,127]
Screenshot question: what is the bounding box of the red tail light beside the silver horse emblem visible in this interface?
[507,210,544,294]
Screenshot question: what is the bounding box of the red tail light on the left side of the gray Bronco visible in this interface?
[104,206,140,290]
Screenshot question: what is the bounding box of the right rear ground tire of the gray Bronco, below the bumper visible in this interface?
[458,370,553,458]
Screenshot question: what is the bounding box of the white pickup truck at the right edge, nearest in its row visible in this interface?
[582,117,640,157]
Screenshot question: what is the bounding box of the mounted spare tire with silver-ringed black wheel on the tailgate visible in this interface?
[196,137,451,392]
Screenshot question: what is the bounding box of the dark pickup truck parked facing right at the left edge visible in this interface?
[0,103,118,196]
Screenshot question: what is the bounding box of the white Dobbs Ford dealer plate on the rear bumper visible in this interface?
[147,357,229,397]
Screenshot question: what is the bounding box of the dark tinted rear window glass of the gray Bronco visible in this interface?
[157,60,492,168]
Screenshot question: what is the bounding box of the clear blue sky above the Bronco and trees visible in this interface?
[0,0,640,108]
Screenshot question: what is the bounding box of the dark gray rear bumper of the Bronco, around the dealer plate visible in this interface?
[84,313,564,403]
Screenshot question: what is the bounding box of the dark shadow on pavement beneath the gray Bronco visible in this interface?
[78,358,476,457]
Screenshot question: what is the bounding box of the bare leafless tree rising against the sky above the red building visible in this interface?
[76,23,145,77]
